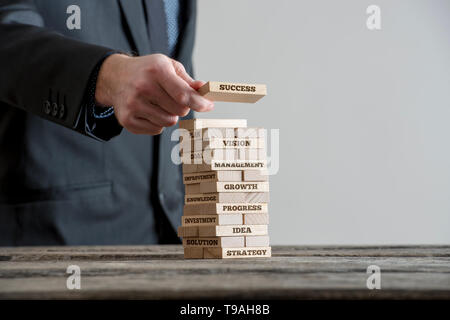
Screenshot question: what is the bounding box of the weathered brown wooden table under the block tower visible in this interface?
[0,245,450,299]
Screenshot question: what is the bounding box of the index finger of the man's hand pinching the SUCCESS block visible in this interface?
[160,63,214,112]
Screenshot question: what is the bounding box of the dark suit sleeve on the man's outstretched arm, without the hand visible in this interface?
[0,1,120,140]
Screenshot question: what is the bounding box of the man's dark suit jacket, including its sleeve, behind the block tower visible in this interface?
[0,0,195,245]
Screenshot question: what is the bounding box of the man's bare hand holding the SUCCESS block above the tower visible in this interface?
[95,54,214,135]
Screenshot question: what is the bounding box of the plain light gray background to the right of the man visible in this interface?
[194,0,450,244]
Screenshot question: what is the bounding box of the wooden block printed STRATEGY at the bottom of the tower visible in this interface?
[203,247,272,259]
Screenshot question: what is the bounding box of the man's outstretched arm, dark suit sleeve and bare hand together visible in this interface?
[0,1,213,140]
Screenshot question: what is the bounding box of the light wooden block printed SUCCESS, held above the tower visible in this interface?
[198,81,267,103]
